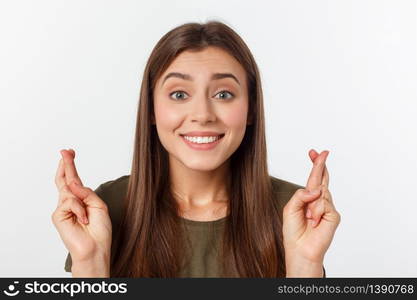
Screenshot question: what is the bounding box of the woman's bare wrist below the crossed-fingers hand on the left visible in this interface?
[71,254,110,278]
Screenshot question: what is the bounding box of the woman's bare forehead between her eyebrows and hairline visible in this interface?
[161,46,245,82]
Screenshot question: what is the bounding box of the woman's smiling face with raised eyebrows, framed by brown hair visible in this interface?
[153,47,248,171]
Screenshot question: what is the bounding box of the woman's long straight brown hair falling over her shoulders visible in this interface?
[110,21,285,277]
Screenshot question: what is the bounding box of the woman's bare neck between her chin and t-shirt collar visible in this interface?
[169,157,230,207]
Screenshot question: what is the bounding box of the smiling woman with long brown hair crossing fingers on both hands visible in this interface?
[52,22,340,277]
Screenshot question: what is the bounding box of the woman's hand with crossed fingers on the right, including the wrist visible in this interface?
[283,150,340,277]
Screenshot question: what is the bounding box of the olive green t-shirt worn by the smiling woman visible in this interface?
[65,175,326,277]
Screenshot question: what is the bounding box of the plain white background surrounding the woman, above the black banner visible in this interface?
[0,0,417,277]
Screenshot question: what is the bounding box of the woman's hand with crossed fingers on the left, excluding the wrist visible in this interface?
[52,150,112,265]
